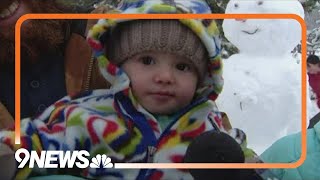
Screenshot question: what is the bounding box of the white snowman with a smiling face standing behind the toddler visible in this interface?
[217,0,315,154]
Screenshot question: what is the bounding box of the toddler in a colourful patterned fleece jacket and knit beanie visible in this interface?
[0,0,258,179]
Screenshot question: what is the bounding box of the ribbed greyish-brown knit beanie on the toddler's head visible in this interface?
[105,20,209,80]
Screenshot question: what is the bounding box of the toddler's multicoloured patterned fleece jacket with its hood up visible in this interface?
[0,0,256,179]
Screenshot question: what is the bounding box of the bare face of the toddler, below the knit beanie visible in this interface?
[122,51,198,115]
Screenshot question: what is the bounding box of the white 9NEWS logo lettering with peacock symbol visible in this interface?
[14,148,113,169]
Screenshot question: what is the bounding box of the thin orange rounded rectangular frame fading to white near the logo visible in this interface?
[15,14,307,169]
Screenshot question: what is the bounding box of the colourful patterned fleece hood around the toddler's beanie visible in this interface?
[87,0,223,100]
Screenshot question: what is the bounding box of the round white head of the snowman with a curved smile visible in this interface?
[222,0,304,56]
